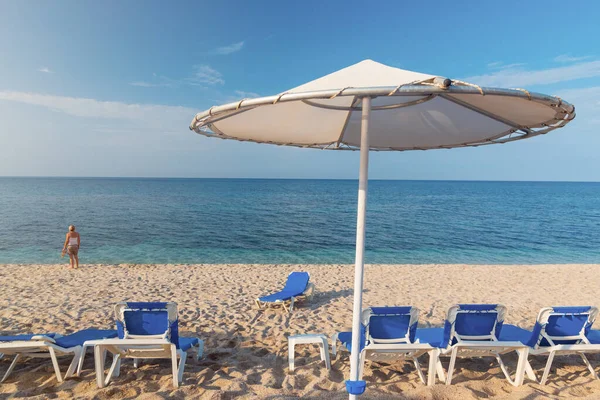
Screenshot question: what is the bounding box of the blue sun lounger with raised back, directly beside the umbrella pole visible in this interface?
[331,306,443,385]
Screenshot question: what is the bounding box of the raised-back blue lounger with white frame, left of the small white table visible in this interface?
[90,302,204,387]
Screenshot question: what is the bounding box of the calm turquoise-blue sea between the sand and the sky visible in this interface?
[0,178,600,264]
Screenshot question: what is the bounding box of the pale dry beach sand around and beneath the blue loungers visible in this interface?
[0,265,600,399]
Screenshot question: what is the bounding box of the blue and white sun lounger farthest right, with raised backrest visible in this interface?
[500,306,600,385]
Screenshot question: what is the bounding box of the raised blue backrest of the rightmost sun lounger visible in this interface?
[527,306,598,348]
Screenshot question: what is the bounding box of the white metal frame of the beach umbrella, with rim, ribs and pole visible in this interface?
[190,71,575,399]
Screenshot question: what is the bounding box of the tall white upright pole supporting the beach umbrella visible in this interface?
[350,97,371,400]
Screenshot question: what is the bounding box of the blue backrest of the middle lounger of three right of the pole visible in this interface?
[442,304,506,348]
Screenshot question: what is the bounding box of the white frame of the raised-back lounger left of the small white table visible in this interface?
[91,302,204,388]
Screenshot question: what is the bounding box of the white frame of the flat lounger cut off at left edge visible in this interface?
[0,335,82,382]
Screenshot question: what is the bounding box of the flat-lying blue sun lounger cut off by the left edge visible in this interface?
[0,328,117,382]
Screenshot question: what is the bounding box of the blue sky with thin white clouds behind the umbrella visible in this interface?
[0,1,600,181]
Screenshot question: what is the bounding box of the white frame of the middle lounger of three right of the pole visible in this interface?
[439,304,535,386]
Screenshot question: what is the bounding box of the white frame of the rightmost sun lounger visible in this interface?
[527,307,600,385]
